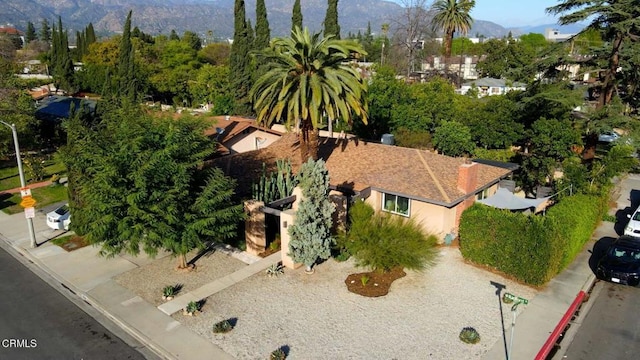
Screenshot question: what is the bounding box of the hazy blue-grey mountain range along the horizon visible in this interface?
[0,0,575,39]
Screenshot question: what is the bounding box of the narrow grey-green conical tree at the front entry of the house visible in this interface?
[289,159,335,271]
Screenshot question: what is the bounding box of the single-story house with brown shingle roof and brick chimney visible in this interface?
[215,133,517,241]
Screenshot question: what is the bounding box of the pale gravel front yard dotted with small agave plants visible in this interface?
[152,247,536,359]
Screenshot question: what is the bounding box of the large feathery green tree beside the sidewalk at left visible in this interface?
[64,102,243,268]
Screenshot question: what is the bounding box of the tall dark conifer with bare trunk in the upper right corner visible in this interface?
[546,0,640,107]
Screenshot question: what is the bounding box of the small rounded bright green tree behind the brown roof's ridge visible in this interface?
[433,120,475,156]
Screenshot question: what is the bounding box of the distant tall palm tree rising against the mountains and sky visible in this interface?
[431,0,476,58]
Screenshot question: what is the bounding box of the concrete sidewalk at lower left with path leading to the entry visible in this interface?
[0,208,280,360]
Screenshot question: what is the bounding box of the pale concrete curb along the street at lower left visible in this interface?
[0,235,177,360]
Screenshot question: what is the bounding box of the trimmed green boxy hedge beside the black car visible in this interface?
[459,195,606,285]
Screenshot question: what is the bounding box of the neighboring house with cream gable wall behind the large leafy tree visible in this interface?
[205,115,282,155]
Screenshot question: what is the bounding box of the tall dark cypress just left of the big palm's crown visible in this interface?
[229,0,253,115]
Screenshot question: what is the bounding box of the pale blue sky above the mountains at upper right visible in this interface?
[392,0,561,27]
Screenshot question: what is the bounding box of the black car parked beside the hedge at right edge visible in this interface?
[596,235,640,286]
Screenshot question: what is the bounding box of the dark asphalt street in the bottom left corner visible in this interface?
[0,243,154,360]
